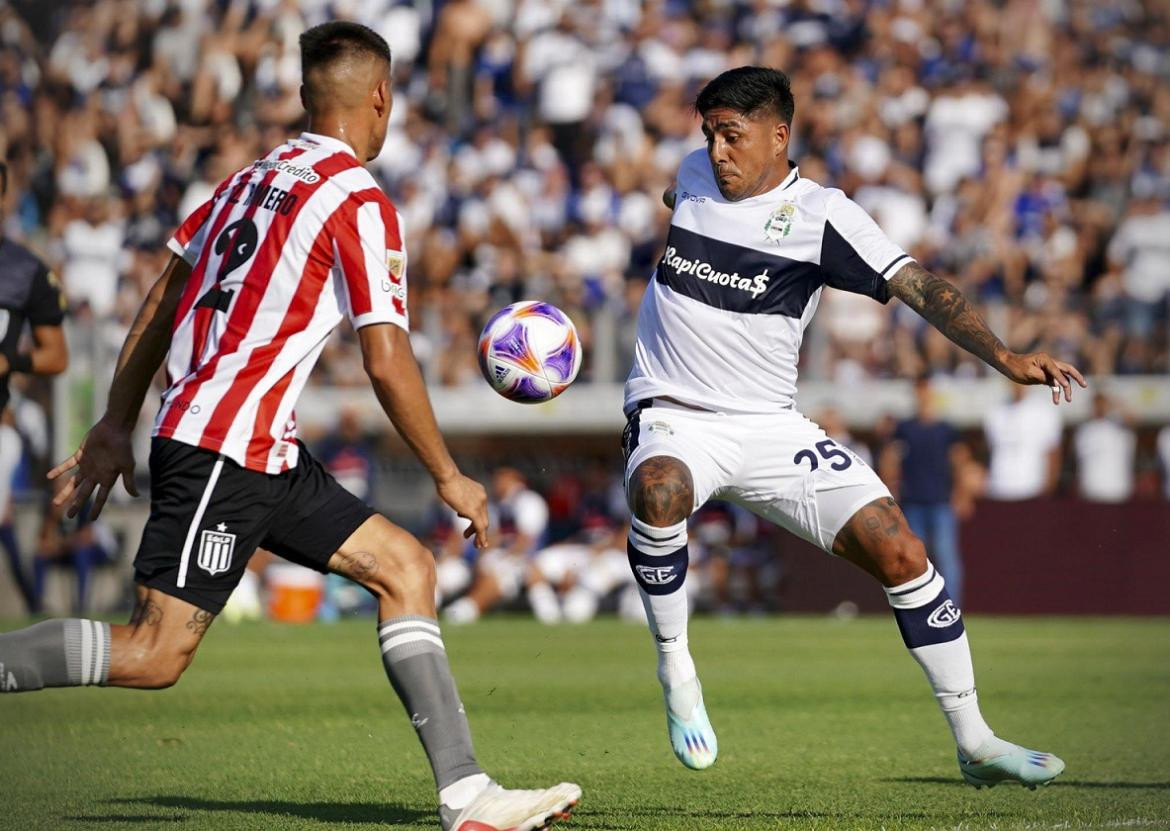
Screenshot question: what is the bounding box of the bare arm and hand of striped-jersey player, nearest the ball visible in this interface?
[358,323,488,548]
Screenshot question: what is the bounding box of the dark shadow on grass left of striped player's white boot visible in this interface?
[97,796,436,825]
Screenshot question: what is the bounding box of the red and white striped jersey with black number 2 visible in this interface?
[154,133,408,473]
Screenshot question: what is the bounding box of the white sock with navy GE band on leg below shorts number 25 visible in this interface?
[886,565,993,760]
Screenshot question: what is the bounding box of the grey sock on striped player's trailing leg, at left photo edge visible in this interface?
[0,618,110,693]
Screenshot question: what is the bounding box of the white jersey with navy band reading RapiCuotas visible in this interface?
[626,150,913,413]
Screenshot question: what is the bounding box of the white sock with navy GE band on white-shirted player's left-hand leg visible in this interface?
[626,516,695,691]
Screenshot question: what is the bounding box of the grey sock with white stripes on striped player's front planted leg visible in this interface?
[378,614,483,790]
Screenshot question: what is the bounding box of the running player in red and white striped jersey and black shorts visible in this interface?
[0,22,580,831]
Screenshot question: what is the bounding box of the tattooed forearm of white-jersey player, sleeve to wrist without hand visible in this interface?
[889,262,1010,372]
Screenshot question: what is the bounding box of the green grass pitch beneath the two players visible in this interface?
[0,618,1170,831]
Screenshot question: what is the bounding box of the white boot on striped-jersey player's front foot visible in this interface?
[439,782,581,831]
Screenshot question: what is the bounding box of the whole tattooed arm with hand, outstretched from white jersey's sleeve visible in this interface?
[889,262,1086,404]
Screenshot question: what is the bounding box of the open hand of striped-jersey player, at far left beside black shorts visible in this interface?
[49,419,138,520]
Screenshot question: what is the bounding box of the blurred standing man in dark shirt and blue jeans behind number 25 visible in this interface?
[883,378,963,606]
